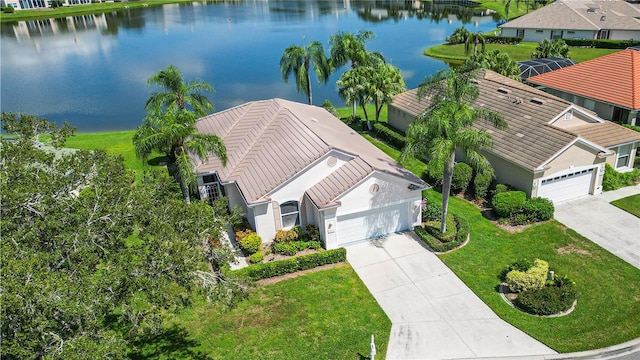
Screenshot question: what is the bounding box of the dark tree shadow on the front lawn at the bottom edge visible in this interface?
[129,325,211,360]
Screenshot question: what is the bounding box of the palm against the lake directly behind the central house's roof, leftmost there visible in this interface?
[280,41,331,105]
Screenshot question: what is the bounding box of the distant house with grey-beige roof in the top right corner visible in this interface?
[500,0,640,42]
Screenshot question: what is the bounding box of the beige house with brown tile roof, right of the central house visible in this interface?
[388,70,640,202]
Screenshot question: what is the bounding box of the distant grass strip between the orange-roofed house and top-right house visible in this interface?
[424,42,619,64]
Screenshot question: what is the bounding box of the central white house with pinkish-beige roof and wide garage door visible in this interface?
[196,99,428,249]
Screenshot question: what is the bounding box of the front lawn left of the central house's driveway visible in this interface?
[139,265,391,360]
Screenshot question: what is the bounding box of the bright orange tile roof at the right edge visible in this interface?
[527,49,640,110]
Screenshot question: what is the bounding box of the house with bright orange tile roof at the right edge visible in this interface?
[527,49,640,125]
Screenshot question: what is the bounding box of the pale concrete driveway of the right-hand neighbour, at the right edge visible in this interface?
[554,185,640,268]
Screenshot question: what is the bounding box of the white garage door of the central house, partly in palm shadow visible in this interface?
[336,203,409,245]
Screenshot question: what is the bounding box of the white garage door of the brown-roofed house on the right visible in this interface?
[538,168,595,203]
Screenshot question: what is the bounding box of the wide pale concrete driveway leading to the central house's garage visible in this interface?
[347,232,555,359]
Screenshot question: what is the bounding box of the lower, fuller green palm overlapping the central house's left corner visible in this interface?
[133,108,227,203]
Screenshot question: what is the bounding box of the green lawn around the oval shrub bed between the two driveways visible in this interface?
[365,135,640,353]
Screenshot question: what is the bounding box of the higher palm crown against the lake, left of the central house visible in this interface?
[144,65,214,116]
